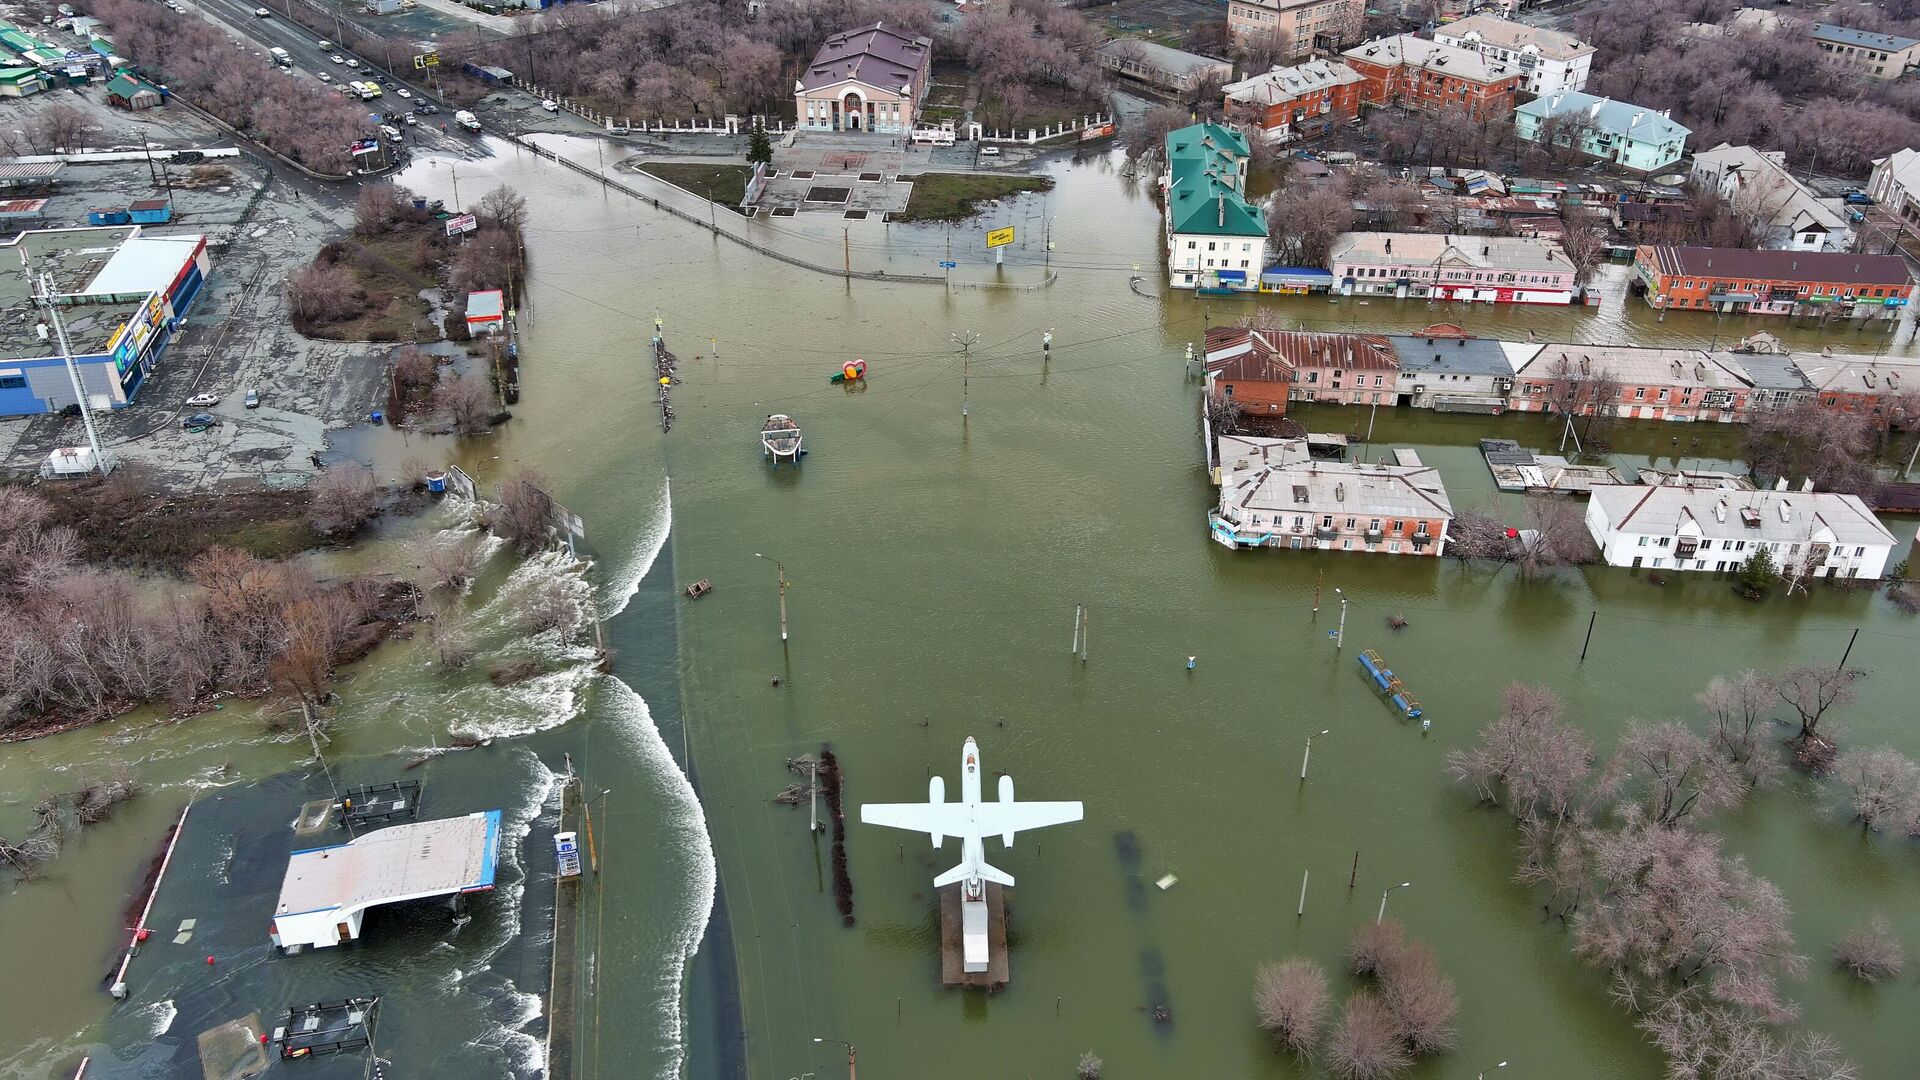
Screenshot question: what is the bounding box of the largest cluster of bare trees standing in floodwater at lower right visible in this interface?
[1448,667,1873,1080]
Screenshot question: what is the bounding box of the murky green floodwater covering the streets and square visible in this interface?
[0,142,1920,1080]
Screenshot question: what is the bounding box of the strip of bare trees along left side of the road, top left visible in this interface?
[92,0,371,175]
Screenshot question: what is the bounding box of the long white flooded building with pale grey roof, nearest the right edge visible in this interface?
[1586,484,1895,580]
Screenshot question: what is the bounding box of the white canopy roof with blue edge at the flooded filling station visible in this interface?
[273,809,499,919]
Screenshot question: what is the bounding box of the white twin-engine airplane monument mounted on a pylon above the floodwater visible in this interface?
[860,736,1083,972]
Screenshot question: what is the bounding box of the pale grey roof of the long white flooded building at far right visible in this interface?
[1594,484,1893,544]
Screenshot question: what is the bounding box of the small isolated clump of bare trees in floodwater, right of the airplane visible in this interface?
[1254,919,1459,1080]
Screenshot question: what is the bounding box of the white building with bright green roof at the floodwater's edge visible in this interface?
[1160,123,1267,292]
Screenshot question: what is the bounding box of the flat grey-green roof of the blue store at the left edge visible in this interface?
[0,225,145,359]
